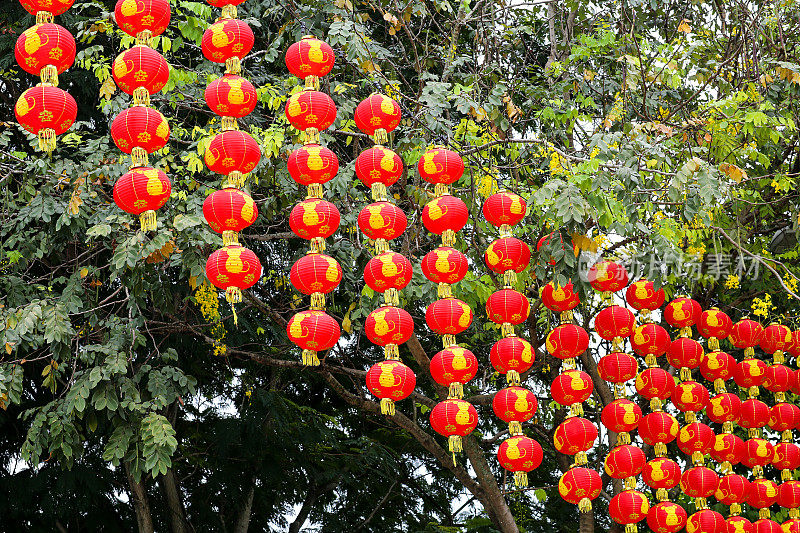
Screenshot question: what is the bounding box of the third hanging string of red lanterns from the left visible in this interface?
[201,0,261,323]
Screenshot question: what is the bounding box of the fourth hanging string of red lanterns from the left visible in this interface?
[286,36,343,366]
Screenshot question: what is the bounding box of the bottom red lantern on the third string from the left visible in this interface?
[206,245,261,302]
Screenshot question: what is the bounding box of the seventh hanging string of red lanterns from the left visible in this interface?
[483,191,544,487]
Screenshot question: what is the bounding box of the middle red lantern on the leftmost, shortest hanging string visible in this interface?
[14,22,75,76]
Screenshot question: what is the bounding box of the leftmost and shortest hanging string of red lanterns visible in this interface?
[14,0,78,153]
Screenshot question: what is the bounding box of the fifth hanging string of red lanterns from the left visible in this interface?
[355,94,416,419]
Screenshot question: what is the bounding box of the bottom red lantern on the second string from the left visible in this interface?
[114,167,172,231]
